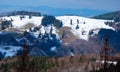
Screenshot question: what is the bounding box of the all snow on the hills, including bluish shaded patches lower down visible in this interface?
[0,15,114,57]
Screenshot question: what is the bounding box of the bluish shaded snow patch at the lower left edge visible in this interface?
[0,45,22,57]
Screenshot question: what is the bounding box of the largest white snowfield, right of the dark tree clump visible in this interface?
[57,16,114,40]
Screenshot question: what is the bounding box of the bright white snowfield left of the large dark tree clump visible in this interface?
[2,15,42,28]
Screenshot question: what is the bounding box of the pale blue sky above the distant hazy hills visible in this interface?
[0,0,120,11]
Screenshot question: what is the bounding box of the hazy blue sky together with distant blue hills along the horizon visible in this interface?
[0,0,120,17]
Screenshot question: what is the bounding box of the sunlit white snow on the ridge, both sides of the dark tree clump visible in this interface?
[2,16,114,40]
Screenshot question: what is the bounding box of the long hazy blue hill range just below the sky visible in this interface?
[0,5,110,17]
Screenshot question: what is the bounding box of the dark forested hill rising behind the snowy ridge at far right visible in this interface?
[92,11,120,20]
